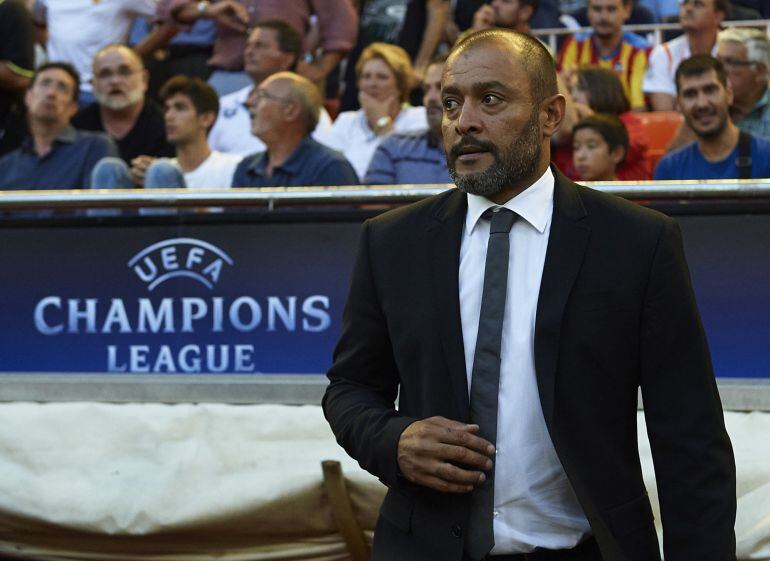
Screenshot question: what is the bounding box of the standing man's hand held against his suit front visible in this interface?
[398,417,495,493]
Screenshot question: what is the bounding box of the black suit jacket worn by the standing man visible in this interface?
[323,171,735,561]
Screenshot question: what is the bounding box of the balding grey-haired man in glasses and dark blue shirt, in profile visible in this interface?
[233,72,358,187]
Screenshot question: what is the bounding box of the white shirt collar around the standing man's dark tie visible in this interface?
[465,167,555,236]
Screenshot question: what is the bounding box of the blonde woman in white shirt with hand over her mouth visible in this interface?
[321,43,427,177]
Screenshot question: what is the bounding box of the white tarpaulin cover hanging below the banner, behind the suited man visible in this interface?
[0,403,770,561]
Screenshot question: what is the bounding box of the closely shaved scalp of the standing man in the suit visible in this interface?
[447,28,559,103]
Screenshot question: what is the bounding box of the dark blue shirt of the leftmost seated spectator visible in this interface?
[0,125,118,190]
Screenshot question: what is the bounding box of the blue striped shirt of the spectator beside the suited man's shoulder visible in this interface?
[364,131,451,185]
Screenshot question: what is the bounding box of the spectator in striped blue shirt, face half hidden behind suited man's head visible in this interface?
[364,56,450,185]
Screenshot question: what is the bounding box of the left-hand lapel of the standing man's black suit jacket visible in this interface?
[426,190,470,421]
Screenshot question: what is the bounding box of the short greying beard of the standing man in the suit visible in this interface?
[447,111,541,197]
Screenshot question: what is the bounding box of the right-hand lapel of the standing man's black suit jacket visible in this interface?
[535,169,591,427]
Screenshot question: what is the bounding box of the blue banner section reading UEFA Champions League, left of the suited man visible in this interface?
[0,223,359,374]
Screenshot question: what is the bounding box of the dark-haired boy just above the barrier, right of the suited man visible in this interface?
[572,113,628,181]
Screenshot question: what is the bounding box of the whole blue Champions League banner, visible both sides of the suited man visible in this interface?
[0,215,770,378]
